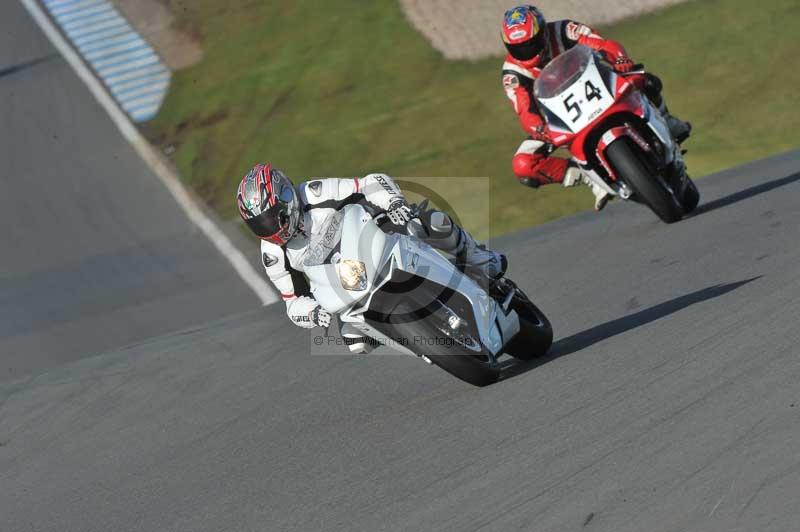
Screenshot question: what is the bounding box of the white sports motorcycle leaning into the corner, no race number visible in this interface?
[304,204,553,386]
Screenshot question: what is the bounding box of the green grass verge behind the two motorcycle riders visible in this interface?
[146,0,800,237]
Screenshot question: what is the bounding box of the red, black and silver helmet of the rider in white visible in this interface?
[236,164,300,246]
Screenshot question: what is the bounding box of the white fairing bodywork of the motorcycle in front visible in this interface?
[305,205,519,354]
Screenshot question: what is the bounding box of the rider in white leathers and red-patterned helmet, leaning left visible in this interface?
[236,164,507,353]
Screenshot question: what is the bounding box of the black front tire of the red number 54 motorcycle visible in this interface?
[606,138,683,224]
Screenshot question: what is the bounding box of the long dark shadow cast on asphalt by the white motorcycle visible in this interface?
[502,276,761,380]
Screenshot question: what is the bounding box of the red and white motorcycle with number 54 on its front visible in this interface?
[534,45,700,223]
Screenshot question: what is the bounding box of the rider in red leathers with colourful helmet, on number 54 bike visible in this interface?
[502,5,691,211]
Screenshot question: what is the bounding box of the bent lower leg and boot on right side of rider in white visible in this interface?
[409,210,508,285]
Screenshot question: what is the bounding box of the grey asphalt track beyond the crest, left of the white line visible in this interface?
[0,0,258,380]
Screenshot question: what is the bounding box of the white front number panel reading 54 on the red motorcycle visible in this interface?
[538,53,614,133]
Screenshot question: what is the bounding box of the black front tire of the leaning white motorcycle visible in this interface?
[394,316,500,386]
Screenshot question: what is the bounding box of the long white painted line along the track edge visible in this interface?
[20,0,278,305]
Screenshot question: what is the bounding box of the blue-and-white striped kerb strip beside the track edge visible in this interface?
[42,0,172,122]
